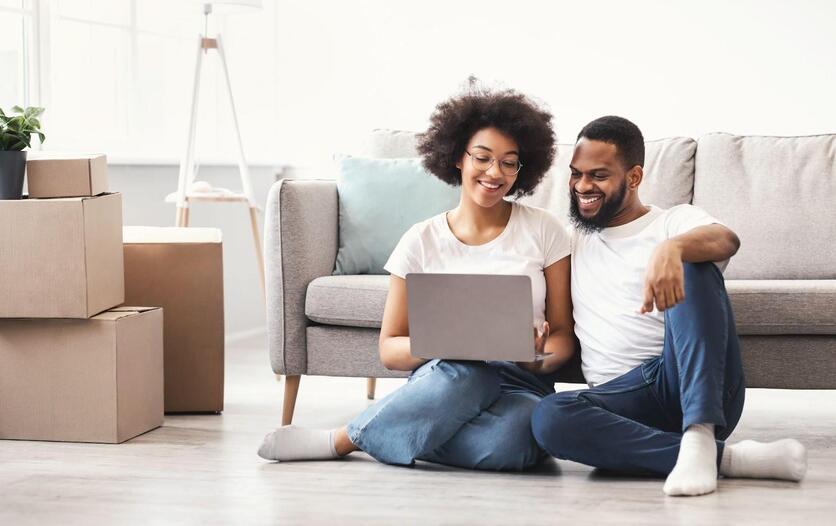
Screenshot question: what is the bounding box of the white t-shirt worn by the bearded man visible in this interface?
[572,204,727,386]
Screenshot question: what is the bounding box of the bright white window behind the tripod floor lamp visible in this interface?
[8,0,277,164]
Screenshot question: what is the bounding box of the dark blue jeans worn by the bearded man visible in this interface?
[531,263,746,475]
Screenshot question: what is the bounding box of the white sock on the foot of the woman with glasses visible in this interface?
[258,425,339,461]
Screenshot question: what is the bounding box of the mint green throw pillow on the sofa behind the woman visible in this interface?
[334,157,459,274]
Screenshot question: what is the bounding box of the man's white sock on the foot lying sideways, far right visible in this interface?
[720,438,807,482]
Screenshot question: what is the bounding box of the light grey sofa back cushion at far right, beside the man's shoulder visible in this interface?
[694,133,836,279]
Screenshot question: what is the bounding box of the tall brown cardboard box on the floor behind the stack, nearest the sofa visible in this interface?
[123,227,224,413]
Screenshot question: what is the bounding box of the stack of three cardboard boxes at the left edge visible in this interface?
[0,156,163,443]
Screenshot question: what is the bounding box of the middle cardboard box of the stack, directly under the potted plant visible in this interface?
[0,194,125,318]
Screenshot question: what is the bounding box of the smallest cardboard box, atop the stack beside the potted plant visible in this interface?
[26,156,107,198]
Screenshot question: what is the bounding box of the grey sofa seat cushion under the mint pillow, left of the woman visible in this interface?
[305,274,389,328]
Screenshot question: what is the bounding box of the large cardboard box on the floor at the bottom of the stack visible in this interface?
[0,307,163,443]
